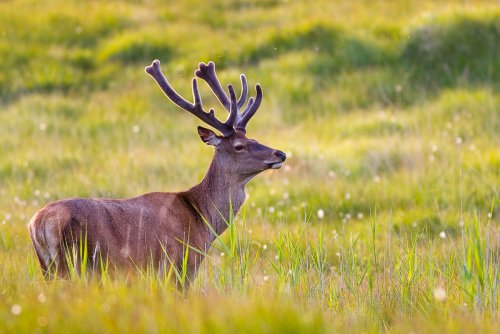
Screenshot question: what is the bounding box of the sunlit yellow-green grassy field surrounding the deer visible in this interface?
[0,0,500,333]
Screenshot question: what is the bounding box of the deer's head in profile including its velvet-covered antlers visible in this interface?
[146,60,286,178]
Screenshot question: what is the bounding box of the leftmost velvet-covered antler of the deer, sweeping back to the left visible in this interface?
[145,60,236,137]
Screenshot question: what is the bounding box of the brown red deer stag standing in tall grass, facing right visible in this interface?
[28,60,286,285]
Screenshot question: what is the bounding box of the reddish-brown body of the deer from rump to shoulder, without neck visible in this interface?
[28,193,195,276]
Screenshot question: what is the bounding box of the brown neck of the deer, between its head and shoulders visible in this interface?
[187,153,248,238]
